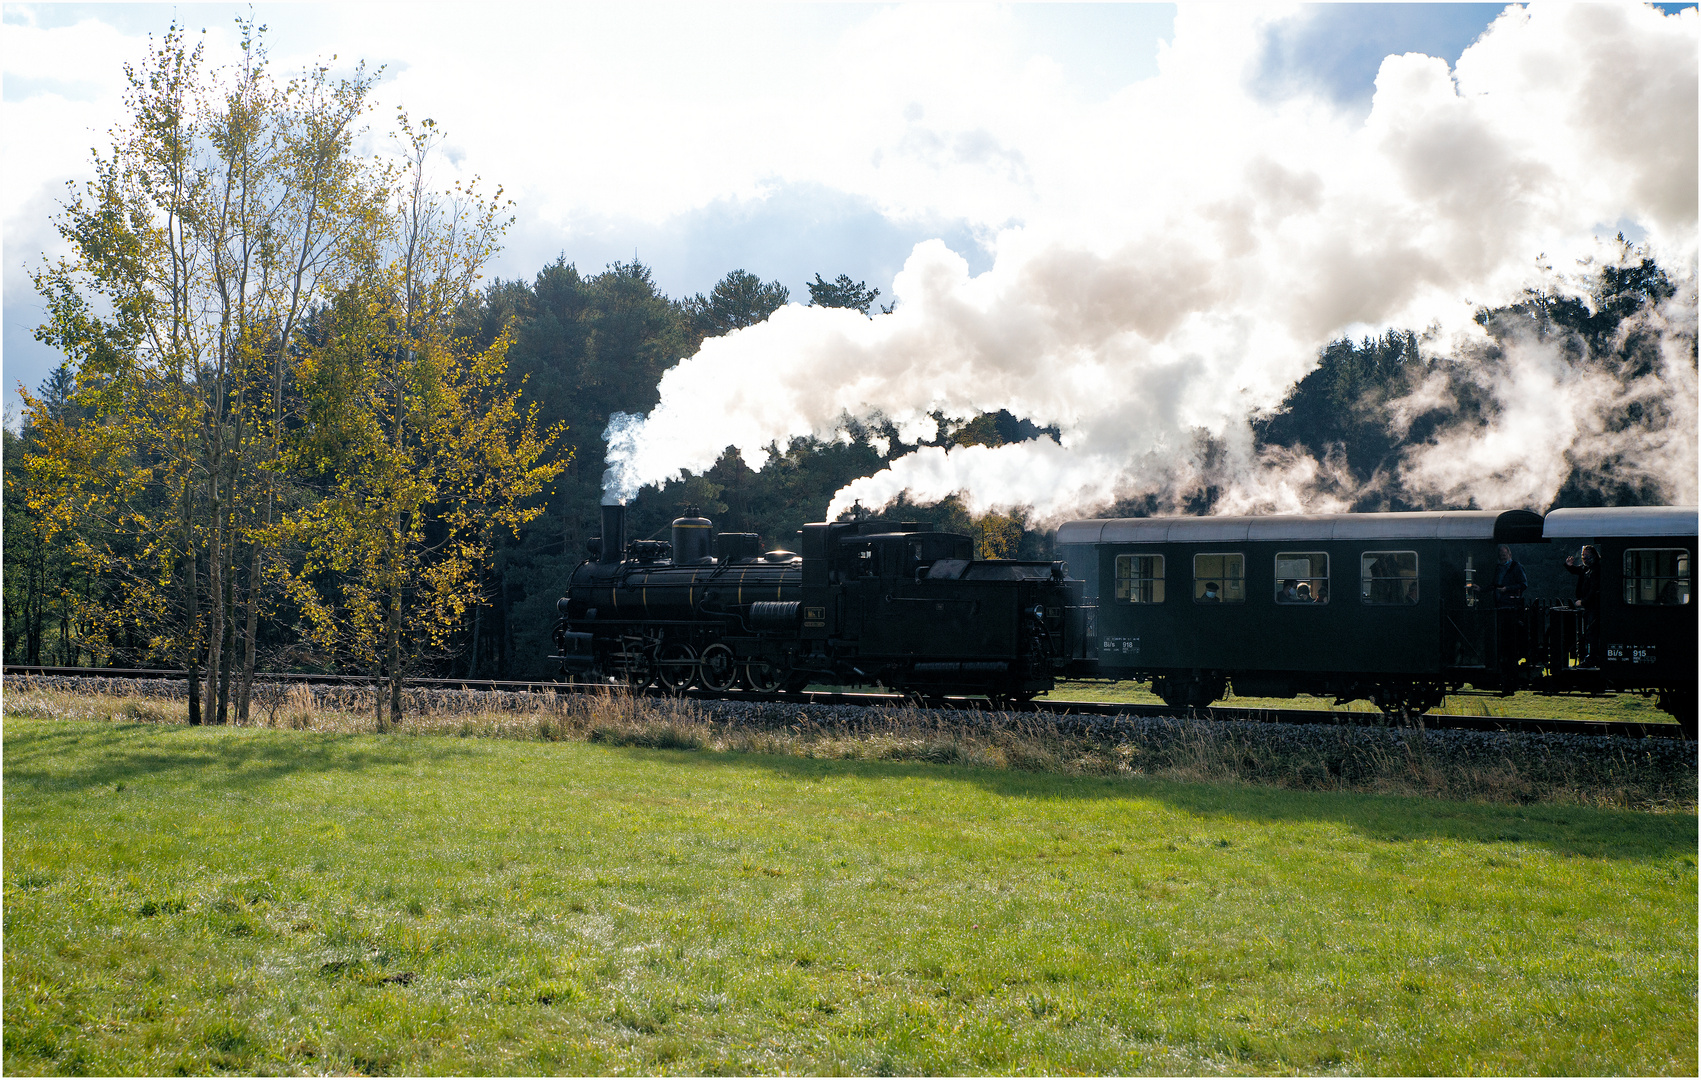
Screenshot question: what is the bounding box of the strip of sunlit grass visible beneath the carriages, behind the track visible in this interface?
[1039,682,1677,725]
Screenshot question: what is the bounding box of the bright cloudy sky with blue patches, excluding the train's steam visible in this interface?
[0,3,1558,413]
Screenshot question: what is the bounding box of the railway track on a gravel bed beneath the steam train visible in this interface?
[3,665,1682,738]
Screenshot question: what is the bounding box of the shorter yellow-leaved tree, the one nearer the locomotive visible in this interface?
[284,114,565,730]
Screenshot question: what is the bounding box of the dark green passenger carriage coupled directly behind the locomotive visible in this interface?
[1058,510,1543,711]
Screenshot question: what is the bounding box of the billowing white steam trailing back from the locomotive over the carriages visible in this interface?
[606,5,1701,522]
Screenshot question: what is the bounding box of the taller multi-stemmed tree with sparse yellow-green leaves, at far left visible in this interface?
[26,20,383,723]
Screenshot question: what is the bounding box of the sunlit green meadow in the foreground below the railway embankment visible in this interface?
[3,716,1698,1075]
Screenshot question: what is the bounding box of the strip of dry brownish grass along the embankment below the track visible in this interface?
[5,677,1696,810]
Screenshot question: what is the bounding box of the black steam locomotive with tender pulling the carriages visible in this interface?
[555,507,1089,704]
